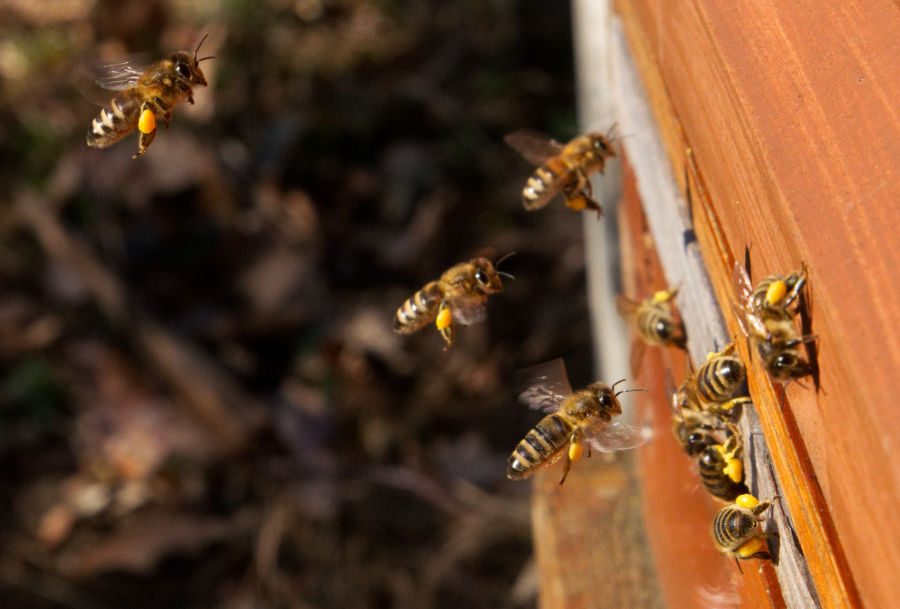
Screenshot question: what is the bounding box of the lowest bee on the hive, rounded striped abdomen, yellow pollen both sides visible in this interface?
[712,494,777,560]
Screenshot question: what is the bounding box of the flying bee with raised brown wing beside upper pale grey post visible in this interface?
[503,130,616,215]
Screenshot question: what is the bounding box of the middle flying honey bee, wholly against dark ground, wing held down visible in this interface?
[394,255,512,349]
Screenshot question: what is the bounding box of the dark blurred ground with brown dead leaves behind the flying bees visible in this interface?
[0,0,592,609]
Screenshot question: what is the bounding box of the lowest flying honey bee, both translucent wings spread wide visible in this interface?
[506,359,649,484]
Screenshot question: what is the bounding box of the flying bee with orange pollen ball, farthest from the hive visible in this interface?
[87,34,213,158]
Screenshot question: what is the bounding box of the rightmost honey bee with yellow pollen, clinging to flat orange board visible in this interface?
[732,263,816,382]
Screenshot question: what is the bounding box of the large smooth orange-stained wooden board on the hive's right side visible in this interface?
[615,0,900,609]
